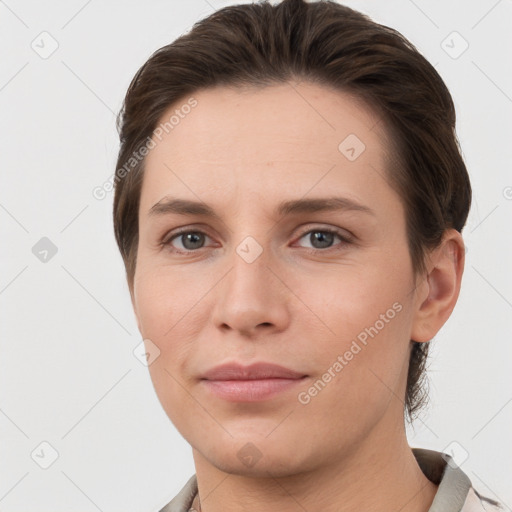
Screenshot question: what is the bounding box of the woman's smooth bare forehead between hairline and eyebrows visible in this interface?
[141,83,389,216]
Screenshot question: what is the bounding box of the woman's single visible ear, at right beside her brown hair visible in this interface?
[411,229,465,342]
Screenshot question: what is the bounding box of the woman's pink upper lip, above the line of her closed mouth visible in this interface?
[201,362,305,380]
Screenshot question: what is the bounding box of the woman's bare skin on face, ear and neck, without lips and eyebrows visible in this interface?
[132,82,464,512]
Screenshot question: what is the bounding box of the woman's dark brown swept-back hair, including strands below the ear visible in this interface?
[113,0,471,420]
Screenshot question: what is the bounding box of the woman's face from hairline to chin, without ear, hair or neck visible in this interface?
[132,83,424,475]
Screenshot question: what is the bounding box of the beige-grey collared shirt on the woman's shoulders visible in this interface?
[160,448,505,512]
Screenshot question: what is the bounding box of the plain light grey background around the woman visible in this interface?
[0,0,512,512]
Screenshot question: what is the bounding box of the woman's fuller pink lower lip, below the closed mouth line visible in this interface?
[201,377,306,402]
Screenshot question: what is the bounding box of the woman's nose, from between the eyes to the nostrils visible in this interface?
[212,245,291,338]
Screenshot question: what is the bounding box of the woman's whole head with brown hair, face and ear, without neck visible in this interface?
[114,0,471,476]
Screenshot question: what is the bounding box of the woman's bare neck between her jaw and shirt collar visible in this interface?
[193,416,437,512]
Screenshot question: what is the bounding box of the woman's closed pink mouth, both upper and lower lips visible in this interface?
[201,362,307,402]
